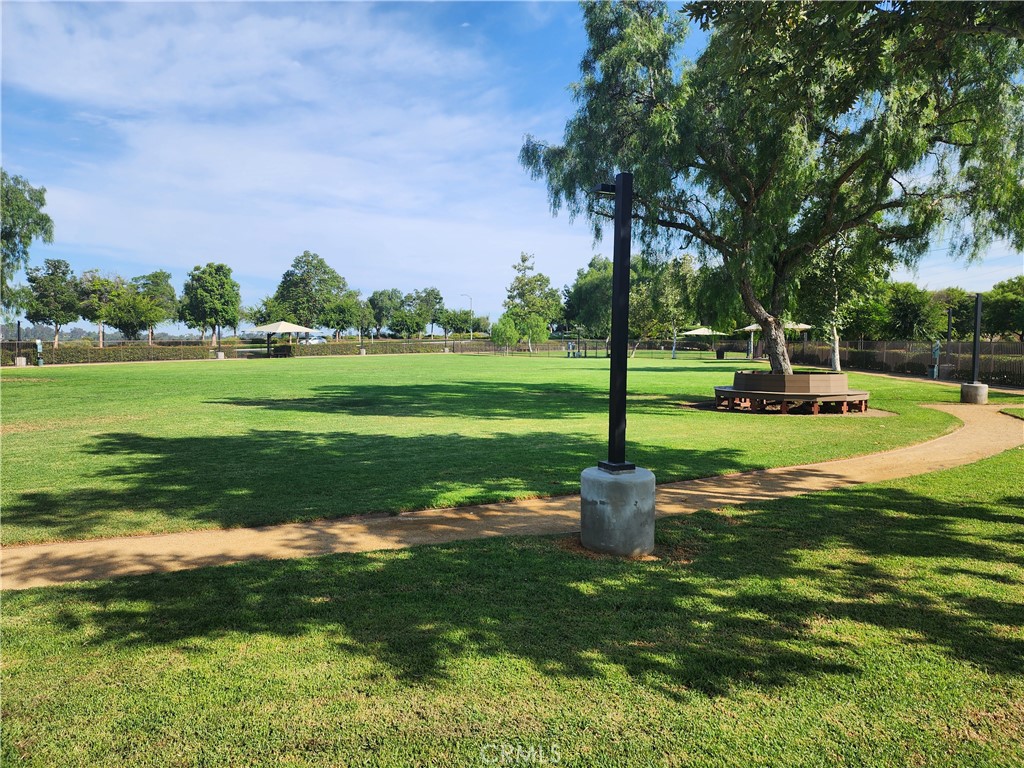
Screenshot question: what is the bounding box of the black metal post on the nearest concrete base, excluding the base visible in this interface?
[594,173,636,472]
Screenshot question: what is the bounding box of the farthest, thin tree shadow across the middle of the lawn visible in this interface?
[211,381,711,420]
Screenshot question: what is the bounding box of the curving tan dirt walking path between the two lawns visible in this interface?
[0,403,1024,590]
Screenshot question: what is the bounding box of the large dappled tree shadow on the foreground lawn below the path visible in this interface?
[29,475,1024,698]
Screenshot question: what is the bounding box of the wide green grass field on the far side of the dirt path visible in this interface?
[0,354,1022,545]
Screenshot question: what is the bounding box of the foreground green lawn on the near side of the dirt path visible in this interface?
[2,448,1024,768]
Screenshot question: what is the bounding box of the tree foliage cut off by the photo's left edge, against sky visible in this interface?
[0,169,53,313]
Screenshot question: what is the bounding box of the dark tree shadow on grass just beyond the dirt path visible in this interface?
[4,430,743,541]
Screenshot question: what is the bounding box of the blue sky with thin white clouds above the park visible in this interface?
[2,2,1022,331]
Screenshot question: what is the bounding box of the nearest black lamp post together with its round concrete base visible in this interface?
[580,173,655,557]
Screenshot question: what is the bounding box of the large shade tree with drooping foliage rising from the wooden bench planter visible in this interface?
[520,2,1024,373]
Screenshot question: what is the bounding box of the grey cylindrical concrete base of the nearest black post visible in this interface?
[580,467,654,557]
